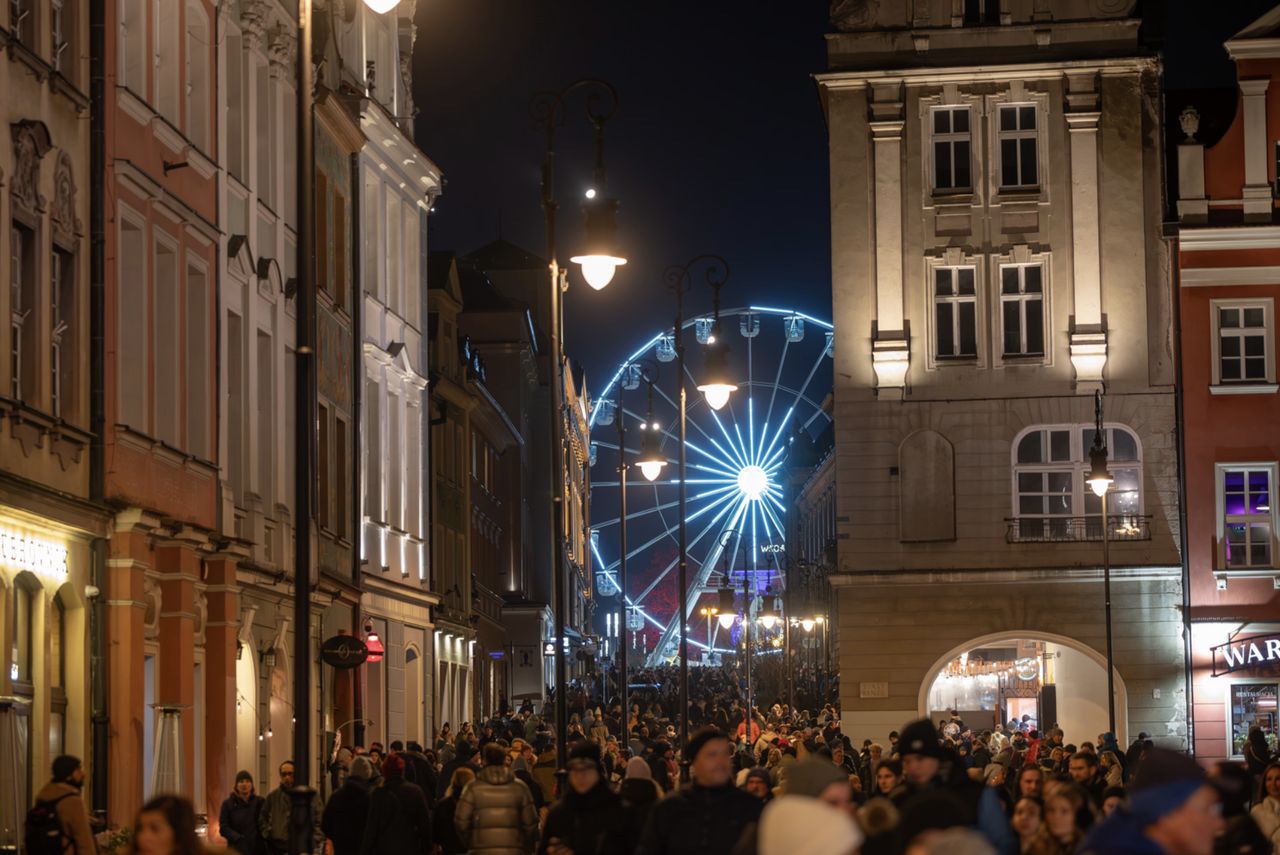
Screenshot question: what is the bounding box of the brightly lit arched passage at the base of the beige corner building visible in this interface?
[919,632,1128,745]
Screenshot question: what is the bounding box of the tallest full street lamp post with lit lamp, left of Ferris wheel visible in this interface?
[531,78,626,790]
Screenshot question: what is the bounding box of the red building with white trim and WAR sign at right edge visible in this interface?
[1172,9,1280,759]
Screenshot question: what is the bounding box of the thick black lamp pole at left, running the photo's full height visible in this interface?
[289,0,316,855]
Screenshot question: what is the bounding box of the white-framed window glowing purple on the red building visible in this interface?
[1217,463,1276,570]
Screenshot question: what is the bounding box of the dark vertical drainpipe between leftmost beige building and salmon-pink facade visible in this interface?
[88,3,110,817]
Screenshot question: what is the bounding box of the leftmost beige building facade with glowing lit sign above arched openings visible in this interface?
[0,1,109,847]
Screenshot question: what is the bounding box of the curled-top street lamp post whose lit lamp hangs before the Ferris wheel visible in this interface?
[663,255,737,783]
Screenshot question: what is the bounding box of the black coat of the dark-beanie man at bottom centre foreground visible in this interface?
[636,783,764,855]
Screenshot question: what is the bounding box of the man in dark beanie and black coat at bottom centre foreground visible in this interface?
[636,727,763,855]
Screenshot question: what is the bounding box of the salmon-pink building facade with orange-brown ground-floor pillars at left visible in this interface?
[100,0,225,824]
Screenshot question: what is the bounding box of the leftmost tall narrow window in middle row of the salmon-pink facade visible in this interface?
[115,218,151,433]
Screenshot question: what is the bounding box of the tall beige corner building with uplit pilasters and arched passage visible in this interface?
[818,0,1188,746]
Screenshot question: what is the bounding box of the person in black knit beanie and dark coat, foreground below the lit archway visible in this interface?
[891,719,1016,855]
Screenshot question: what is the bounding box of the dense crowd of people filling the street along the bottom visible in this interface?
[24,669,1280,855]
